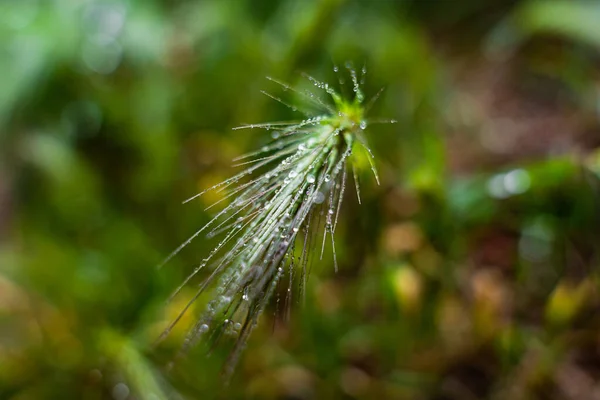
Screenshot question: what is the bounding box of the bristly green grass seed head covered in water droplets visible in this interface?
[159,63,395,375]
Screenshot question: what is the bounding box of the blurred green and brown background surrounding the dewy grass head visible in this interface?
[0,0,600,400]
